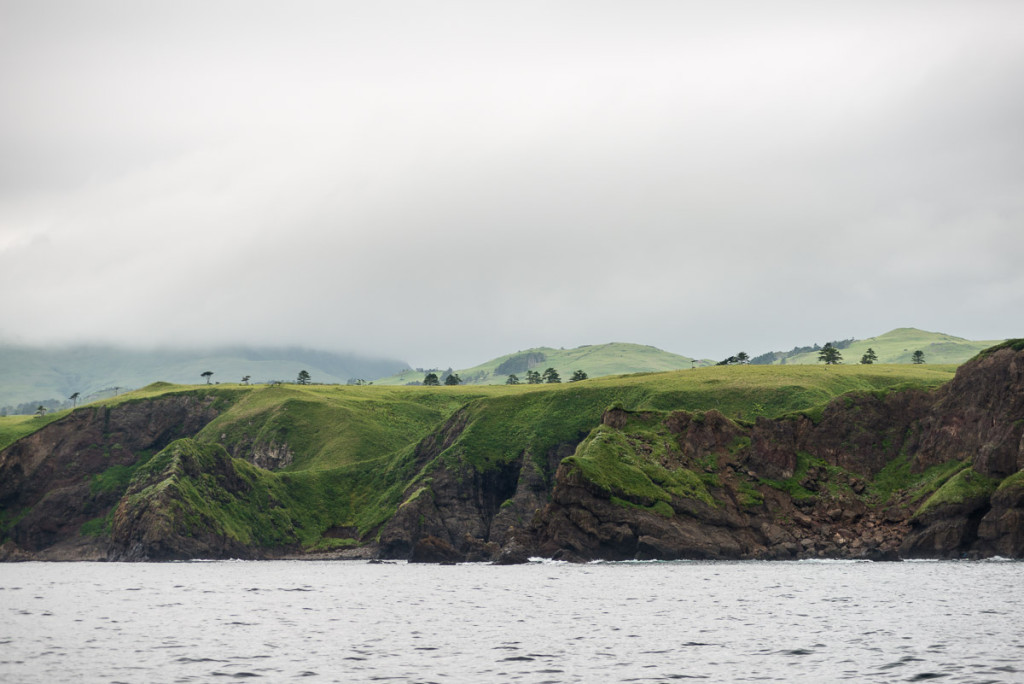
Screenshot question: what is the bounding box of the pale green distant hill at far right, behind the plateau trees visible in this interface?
[751,328,1002,365]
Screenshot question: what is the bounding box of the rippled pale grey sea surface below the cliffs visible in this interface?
[0,561,1024,683]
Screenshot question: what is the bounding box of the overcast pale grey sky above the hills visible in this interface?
[0,0,1024,368]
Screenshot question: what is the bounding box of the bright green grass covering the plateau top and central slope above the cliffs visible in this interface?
[0,365,955,550]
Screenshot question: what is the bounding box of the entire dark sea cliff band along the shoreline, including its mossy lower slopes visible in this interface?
[0,341,1024,562]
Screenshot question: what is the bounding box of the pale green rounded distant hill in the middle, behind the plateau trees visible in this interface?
[374,342,712,385]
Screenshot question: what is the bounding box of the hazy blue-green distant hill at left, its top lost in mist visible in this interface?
[0,345,409,413]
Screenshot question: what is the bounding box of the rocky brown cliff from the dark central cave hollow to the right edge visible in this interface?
[381,342,1024,561]
